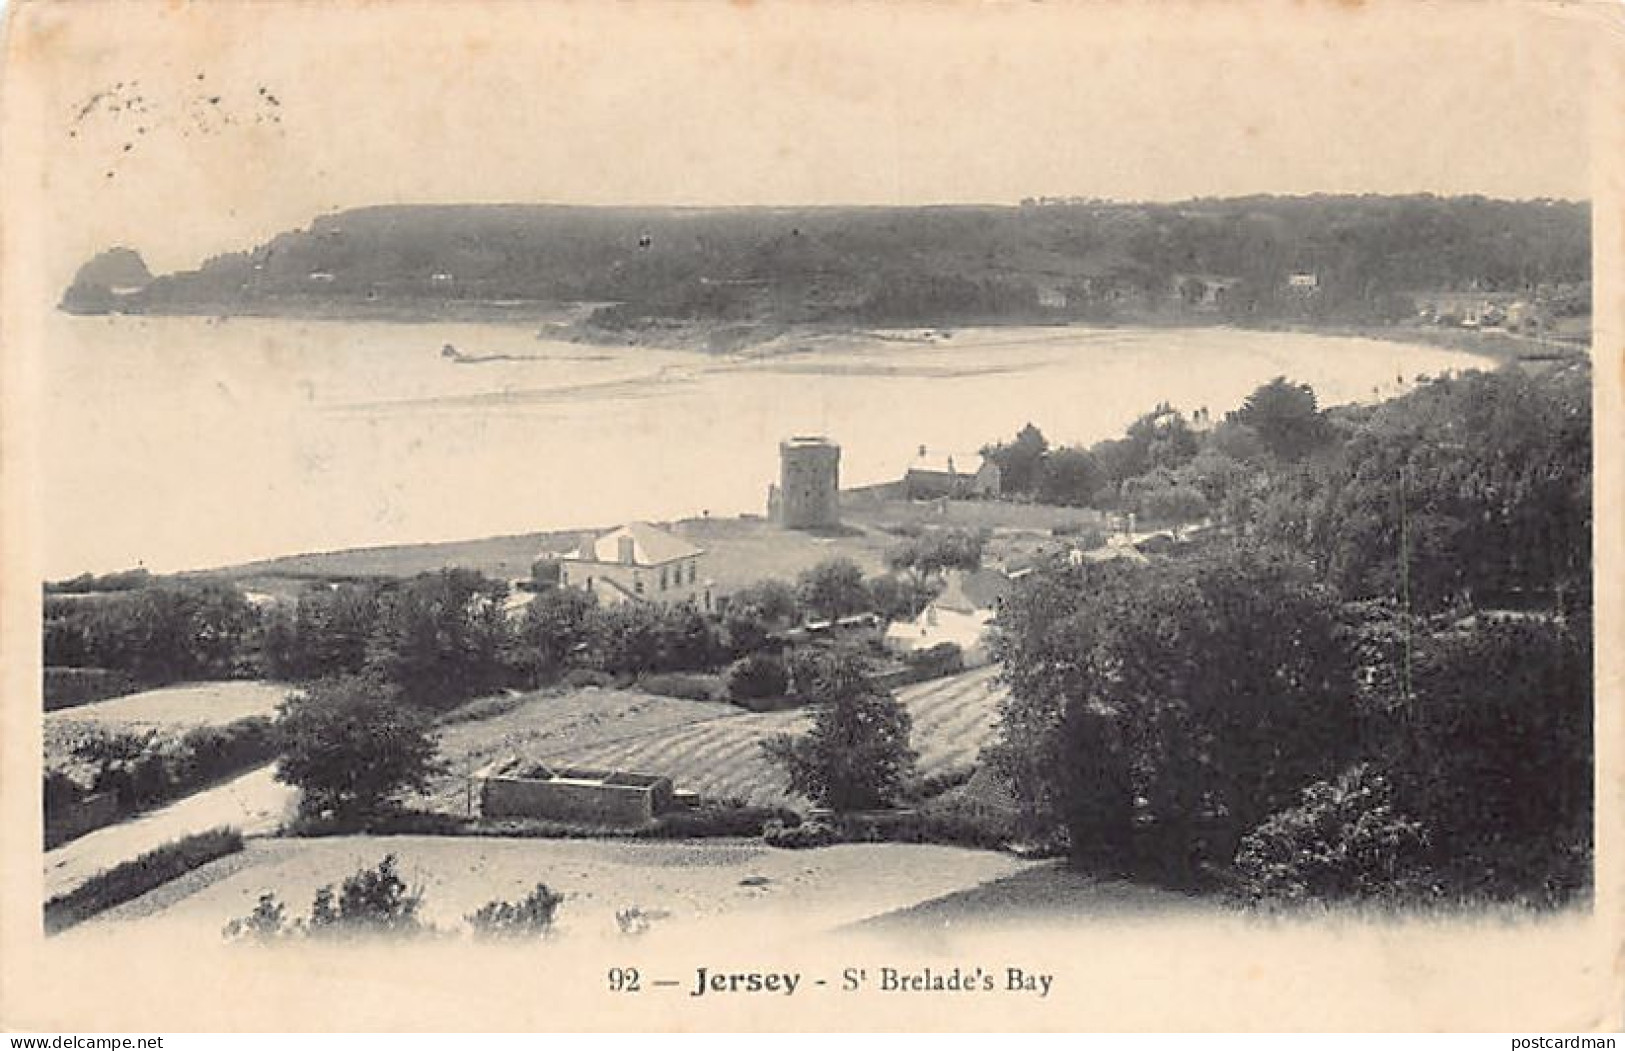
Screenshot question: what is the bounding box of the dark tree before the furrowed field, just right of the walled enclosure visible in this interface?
[762,653,917,811]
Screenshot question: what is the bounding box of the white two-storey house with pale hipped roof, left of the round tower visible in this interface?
[559,521,712,611]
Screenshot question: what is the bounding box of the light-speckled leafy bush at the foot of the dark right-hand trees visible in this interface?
[1235,763,1427,902]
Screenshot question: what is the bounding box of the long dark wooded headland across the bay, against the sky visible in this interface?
[63,195,1591,330]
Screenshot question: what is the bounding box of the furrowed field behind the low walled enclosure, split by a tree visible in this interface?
[427,668,1003,814]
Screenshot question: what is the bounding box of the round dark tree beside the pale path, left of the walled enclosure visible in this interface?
[276,676,442,819]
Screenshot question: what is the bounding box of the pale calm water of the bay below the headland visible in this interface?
[39,315,1489,577]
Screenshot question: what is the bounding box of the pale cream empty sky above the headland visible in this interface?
[7,0,1597,289]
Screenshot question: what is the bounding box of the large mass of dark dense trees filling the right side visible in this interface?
[990,369,1593,903]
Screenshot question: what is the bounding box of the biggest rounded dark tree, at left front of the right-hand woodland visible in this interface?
[990,547,1354,880]
